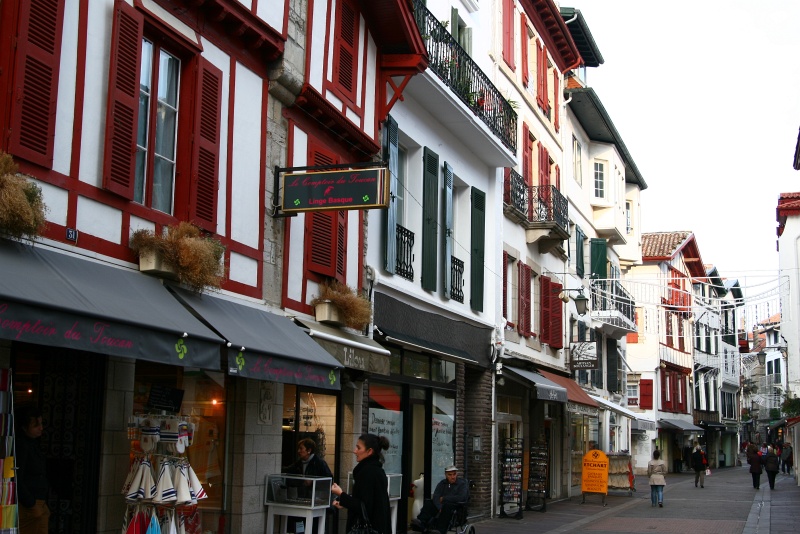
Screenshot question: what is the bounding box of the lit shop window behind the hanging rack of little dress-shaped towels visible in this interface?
[133,361,227,531]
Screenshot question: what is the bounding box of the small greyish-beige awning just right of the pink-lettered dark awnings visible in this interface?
[294,319,391,376]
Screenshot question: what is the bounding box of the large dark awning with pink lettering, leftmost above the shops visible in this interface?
[0,239,223,370]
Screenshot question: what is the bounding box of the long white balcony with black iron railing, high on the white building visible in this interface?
[406,0,517,166]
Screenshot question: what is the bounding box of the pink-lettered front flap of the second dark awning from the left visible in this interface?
[228,348,341,390]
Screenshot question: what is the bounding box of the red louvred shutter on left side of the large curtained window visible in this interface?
[103,0,144,200]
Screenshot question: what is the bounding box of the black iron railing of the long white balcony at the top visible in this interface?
[413,0,517,152]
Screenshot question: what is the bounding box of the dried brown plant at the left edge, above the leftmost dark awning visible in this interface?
[0,152,47,239]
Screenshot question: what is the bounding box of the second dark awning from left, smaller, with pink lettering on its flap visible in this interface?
[170,286,342,390]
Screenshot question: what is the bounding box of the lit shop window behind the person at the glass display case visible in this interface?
[282,384,337,478]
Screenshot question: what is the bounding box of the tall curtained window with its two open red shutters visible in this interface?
[103,2,222,232]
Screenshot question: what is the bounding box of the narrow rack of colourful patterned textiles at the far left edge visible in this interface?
[0,369,19,534]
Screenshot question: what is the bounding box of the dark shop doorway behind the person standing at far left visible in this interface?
[11,345,105,534]
